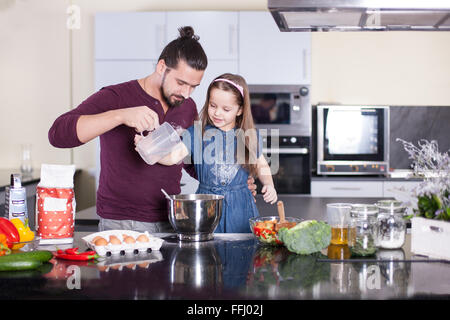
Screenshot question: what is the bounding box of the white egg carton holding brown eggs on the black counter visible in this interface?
[82,230,164,257]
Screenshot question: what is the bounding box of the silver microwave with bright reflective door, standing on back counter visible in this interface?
[317,105,389,175]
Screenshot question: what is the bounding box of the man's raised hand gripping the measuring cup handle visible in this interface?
[118,106,159,132]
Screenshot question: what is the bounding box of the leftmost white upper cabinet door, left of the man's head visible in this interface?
[95,12,166,59]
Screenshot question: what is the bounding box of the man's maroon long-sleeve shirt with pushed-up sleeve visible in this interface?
[48,80,198,222]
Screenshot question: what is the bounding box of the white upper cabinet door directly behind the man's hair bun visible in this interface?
[167,11,238,60]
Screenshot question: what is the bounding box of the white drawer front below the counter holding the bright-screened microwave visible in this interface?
[311,181,383,198]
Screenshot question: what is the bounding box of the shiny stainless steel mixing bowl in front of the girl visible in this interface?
[167,194,223,241]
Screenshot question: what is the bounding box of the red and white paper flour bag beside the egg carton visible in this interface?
[36,164,76,244]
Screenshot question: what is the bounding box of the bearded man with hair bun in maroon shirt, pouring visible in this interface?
[48,27,256,232]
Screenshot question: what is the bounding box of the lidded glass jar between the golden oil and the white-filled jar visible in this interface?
[349,204,378,256]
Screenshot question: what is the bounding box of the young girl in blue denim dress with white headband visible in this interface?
[138,73,277,233]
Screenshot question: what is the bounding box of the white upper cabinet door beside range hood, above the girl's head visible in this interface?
[239,11,311,84]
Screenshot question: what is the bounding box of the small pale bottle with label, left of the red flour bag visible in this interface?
[5,173,28,223]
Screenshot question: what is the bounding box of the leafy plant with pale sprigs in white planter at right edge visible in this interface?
[397,139,450,221]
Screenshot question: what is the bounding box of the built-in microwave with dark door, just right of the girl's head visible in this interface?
[248,85,312,137]
